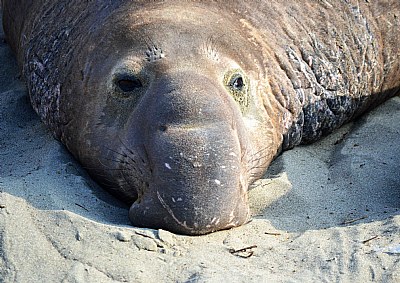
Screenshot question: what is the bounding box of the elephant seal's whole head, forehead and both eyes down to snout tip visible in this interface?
[62,7,278,234]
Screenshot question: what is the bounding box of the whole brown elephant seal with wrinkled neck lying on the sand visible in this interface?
[2,0,400,235]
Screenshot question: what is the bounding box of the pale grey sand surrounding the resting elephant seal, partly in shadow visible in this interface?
[0,15,400,283]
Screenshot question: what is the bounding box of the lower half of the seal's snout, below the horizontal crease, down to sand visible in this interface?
[129,123,249,235]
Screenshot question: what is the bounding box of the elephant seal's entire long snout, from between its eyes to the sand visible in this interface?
[129,73,249,235]
